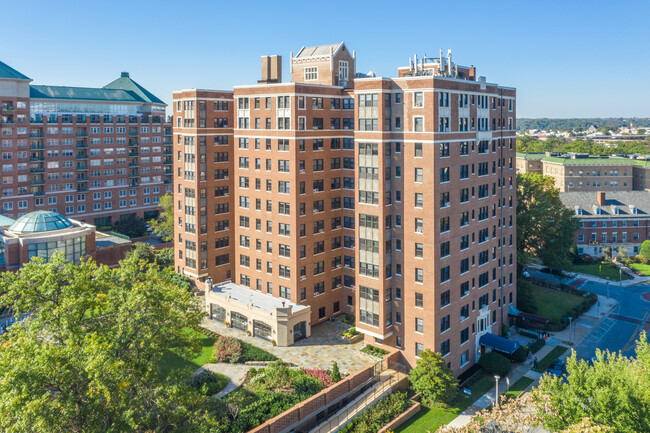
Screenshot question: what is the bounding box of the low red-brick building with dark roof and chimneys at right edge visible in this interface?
[560,191,650,257]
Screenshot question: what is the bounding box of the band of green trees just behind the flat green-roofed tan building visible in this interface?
[517,136,650,155]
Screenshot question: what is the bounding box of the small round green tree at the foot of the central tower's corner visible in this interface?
[409,350,458,406]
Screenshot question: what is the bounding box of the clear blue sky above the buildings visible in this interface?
[0,0,650,117]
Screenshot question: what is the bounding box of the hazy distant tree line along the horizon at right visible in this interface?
[517,117,650,132]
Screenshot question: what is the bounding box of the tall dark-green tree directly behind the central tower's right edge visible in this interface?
[517,173,580,269]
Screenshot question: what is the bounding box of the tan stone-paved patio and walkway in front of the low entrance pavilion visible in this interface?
[203,319,379,373]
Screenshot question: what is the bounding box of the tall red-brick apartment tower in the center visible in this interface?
[174,43,516,374]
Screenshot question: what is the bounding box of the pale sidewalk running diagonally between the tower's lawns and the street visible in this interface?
[447,292,618,428]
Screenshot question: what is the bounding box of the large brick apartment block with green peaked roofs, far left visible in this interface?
[0,62,172,227]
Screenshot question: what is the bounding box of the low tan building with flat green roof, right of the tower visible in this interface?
[517,152,650,192]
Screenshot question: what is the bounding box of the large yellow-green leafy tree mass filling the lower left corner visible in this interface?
[0,254,215,433]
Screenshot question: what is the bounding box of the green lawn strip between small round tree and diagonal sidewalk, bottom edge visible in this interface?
[396,373,494,433]
